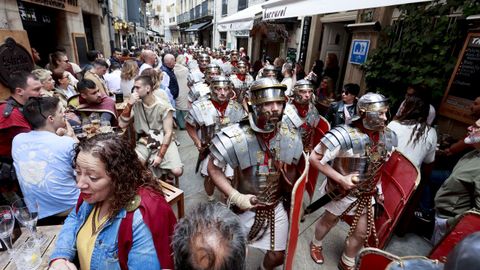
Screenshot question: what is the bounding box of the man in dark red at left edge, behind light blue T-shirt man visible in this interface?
[0,71,42,202]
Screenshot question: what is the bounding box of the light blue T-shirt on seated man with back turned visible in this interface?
[12,131,80,219]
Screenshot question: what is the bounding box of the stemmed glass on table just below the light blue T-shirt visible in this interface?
[12,199,46,247]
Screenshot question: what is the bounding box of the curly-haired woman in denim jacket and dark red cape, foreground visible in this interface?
[50,134,176,269]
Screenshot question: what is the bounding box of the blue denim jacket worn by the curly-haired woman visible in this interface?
[50,202,160,270]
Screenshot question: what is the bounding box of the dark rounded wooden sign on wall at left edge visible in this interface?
[0,37,33,85]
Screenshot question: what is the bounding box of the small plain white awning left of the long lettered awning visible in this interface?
[217,4,262,32]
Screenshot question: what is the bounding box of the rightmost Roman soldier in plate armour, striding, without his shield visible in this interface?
[307,93,397,270]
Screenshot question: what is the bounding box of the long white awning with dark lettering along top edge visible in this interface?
[262,0,431,20]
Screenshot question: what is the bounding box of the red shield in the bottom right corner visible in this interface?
[428,211,480,262]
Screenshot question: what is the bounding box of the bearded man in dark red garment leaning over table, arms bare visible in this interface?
[68,79,118,127]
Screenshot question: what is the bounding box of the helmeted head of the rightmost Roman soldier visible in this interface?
[352,93,389,131]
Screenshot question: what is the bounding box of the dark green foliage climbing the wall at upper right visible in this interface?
[362,0,480,107]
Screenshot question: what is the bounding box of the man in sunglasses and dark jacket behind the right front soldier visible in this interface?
[325,83,360,128]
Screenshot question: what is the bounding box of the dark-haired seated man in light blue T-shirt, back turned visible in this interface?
[12,97,79,224]
